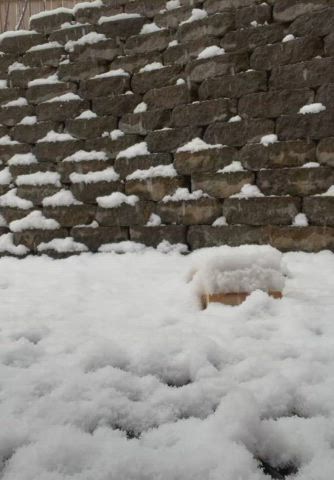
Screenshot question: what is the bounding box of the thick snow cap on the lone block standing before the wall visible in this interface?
[191,245,285,294]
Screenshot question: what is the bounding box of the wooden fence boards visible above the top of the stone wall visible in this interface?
[0,0,91,32]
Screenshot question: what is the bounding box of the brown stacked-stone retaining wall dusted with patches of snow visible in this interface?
[0,0,334,256]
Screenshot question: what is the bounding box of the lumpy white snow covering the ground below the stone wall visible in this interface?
[0,251,334,480]
